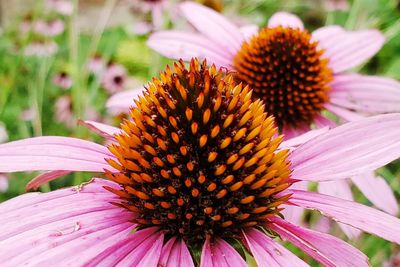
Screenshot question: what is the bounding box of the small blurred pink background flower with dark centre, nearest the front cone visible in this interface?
[102,63,127,94]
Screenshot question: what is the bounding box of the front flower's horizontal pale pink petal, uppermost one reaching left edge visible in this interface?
[0,136,114,172]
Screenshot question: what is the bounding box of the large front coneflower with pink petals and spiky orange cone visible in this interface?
[0,60,400,267]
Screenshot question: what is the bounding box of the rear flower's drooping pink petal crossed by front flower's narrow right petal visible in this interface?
[318,180,361,239]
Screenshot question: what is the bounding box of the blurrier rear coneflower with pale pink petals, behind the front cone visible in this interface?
[148,2,400,136]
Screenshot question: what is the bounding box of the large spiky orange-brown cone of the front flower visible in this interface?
[107,60,291,244]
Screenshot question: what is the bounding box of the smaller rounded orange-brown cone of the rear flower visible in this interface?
[234,27,332,128]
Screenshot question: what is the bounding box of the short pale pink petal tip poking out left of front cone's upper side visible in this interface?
[106,87,144,114]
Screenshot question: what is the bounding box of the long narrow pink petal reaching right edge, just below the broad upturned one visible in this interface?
[288,190,400,244]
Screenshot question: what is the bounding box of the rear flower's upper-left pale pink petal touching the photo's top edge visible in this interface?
[179,1,244,54]
